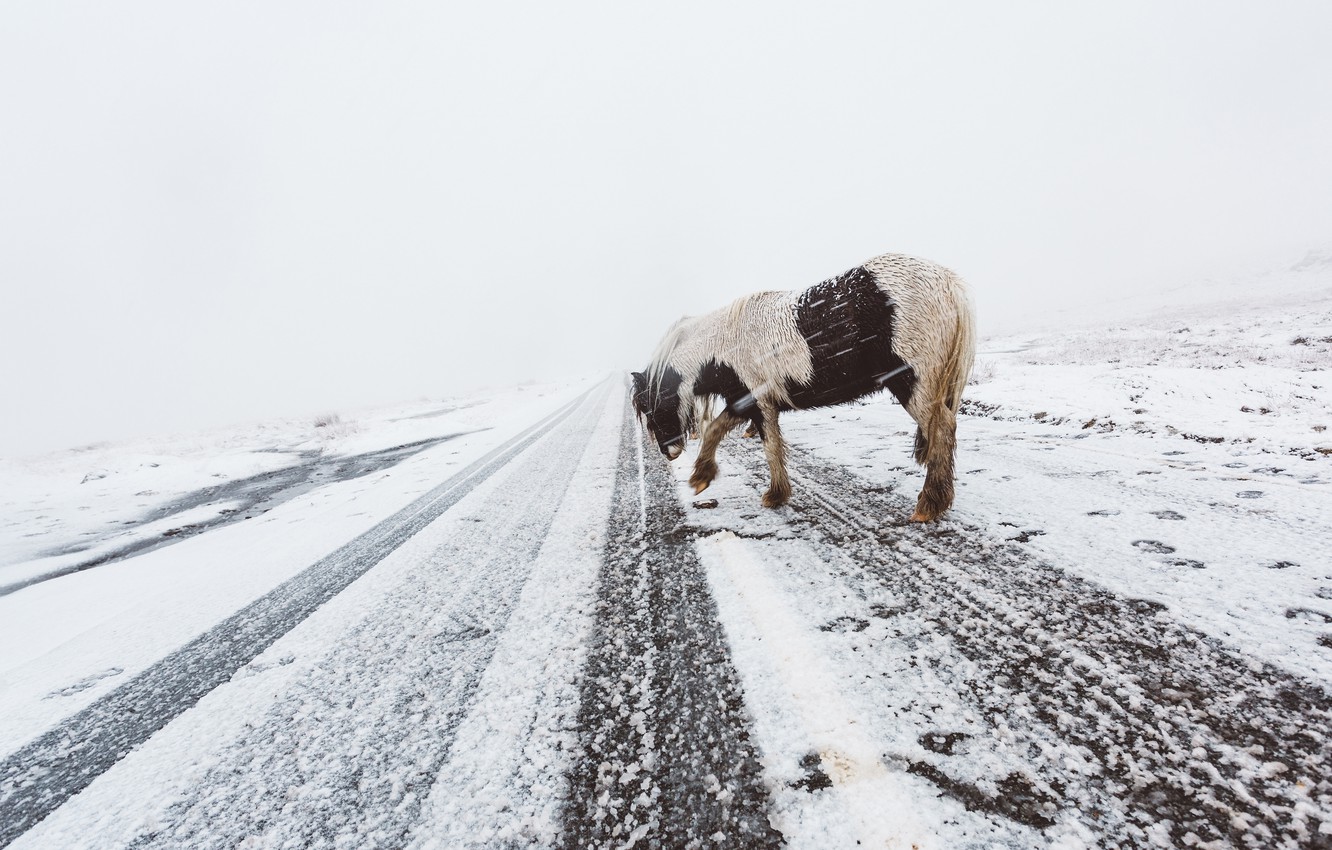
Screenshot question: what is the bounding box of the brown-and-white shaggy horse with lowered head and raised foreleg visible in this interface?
[633,254,975,522]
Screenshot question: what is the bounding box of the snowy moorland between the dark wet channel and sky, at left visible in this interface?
[0,382,585,586]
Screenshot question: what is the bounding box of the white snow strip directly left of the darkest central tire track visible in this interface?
[408,388,623,850]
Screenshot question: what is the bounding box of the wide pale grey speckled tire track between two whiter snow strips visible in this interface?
[101,382,610,850]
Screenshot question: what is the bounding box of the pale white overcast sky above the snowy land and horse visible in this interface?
[0,0,1332,454]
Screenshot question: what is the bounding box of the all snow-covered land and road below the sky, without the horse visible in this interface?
[0,256,1332,849]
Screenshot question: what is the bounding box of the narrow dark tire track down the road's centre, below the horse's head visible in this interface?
[562,405,781,850]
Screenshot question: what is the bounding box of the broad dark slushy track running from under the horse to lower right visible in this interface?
[731,441,1332,849]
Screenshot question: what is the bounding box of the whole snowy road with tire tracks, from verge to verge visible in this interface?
[0,381,1332,850]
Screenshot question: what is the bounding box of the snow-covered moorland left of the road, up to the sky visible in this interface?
[0,378,597,753]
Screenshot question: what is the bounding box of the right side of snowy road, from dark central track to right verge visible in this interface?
[694,436,1332,847]
